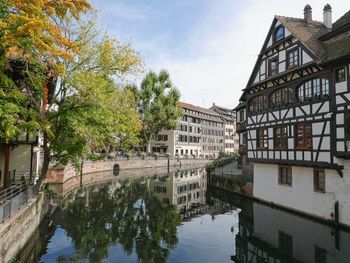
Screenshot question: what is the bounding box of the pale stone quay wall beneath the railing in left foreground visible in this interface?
[0,192,49,263]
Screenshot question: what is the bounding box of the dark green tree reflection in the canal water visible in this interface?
[57,182,181,262]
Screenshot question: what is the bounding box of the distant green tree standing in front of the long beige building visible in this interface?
[128,70,182,153]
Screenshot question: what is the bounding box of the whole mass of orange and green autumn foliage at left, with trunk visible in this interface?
[0,0,141,176]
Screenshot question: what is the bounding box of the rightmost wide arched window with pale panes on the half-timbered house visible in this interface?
[297,78,329,102]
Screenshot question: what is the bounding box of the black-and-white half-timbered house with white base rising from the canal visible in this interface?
[235,4,350,229]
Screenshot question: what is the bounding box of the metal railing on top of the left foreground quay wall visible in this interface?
[0,182,39,223]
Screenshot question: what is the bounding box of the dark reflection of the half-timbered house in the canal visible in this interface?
[211,187,350,263]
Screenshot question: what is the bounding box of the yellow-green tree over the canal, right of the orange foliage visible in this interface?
[42,20,141,177]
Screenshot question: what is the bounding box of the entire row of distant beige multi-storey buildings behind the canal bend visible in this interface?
[151,102,239,157]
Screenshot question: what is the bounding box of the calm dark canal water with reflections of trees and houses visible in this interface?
[18,169,350,263]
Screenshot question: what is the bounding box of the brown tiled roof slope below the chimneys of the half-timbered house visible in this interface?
[276,16,329,62]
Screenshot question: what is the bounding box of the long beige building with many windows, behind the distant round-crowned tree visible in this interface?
[151,102,225,157]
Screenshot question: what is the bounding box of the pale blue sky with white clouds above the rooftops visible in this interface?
[91,0,350,108]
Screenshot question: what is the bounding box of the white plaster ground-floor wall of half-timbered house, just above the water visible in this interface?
[253,161,350,226]
